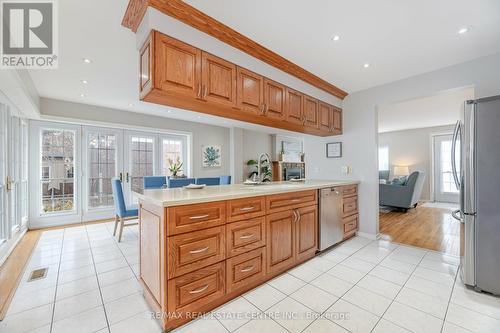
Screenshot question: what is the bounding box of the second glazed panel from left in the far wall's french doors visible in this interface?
[83,127,123,220]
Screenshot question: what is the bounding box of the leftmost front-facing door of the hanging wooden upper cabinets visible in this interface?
[155,34,201,98]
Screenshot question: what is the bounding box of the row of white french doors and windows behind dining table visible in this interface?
[30,121,188,227]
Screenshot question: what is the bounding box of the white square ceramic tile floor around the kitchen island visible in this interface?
[0,223,500,333]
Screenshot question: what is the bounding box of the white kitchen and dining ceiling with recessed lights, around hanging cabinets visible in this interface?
[30,0,500,126]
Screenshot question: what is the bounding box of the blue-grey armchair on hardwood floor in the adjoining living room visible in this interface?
[379,171,425,212]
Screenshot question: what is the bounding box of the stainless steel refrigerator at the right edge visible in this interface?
[452,96,500,294]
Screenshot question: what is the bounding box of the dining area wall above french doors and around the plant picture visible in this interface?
[40,98,231,177]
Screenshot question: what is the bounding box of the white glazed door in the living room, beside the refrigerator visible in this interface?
[433,134,460,203]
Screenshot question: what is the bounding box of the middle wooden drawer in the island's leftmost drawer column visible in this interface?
[167,227,226,278]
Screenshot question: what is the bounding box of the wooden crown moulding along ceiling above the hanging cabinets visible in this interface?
[122,0,347,99]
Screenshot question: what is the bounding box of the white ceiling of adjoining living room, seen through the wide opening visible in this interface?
[378,88,474,133]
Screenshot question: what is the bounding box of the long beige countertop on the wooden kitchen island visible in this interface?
[134,180,359,207]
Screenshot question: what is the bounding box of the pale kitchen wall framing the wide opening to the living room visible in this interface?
[340,54,500,235]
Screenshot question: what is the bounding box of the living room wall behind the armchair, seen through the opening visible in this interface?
[378,124,459,200]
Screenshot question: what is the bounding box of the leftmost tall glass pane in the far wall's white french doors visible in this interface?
[40,129,75,214]
